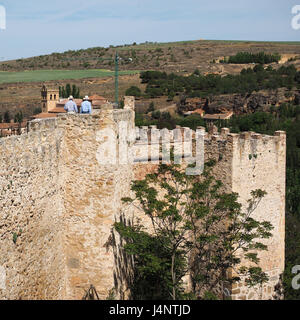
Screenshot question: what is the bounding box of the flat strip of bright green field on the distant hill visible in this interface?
[0,69,139,84]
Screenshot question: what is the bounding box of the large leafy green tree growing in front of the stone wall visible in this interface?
[115,161,272,300]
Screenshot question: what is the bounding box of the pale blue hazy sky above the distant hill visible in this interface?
[0,0,300,61]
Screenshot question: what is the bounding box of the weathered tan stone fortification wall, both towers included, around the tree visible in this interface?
[0,97,286,299]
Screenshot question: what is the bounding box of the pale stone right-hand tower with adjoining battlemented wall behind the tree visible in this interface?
[134,127,286,300]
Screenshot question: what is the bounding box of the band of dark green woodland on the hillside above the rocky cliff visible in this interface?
[141,64,300,98]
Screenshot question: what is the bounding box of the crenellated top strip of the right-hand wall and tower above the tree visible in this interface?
[134,126,286,162]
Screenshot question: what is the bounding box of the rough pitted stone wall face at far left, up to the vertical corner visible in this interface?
[0,120,64,299]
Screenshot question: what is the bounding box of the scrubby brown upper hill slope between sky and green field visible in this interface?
[0,40,300,74]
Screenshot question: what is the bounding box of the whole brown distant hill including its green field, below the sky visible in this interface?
[0,40,300,120]
